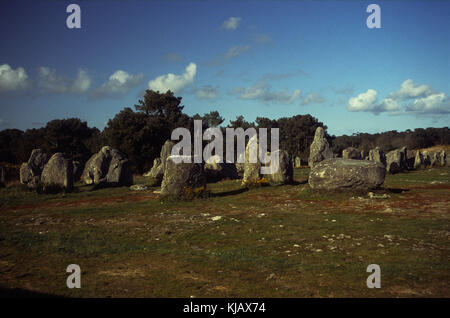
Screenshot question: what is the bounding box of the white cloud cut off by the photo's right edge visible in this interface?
[406,93,450,115]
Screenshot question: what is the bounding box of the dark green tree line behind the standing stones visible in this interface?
[0,90,450,173]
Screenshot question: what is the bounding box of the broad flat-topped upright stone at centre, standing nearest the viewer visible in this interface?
[161,156,206,198]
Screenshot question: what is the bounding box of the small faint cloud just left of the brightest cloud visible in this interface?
[91,70,144,97]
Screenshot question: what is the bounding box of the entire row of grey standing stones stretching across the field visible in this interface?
[11,127,448,197]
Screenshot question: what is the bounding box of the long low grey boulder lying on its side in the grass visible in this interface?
[308,158,386,190]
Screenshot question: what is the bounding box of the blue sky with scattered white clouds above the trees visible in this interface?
[0,0,450,135]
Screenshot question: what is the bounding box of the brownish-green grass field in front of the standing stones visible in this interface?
[0,168,450,297]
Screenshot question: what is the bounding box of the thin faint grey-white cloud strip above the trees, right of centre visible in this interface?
[234,83,301,104]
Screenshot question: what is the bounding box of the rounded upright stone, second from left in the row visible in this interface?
[41,152,73,191]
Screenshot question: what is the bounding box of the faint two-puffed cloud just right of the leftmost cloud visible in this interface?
[37,66,91,94]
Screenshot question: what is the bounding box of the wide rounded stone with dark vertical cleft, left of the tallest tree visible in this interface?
[81,146,133,186]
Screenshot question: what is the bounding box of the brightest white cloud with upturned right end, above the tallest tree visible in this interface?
[148,63,197,93]
